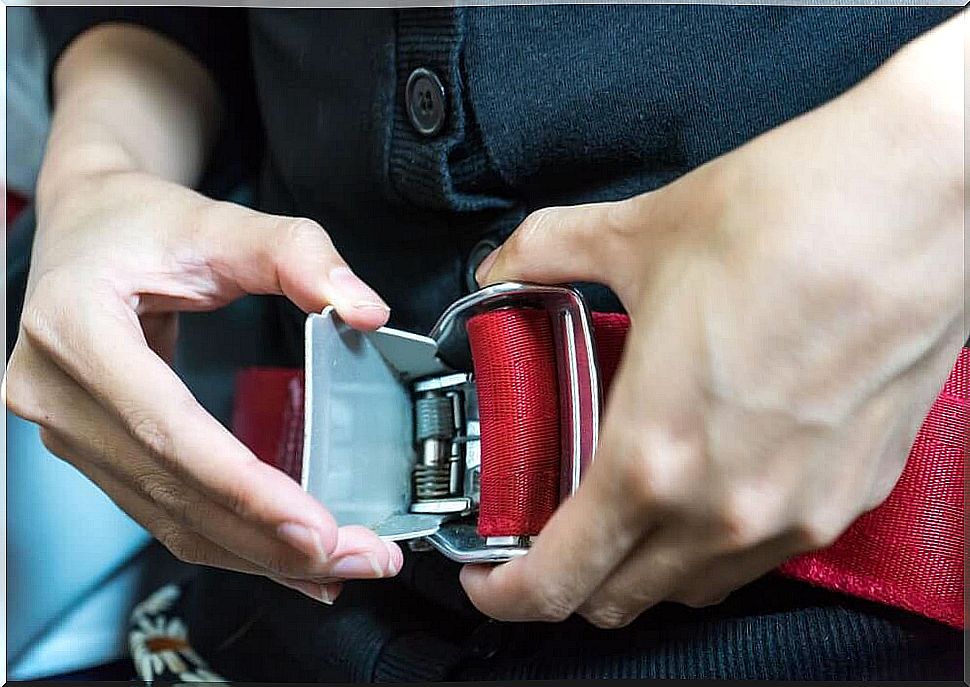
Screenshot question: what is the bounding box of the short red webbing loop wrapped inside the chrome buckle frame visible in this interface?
[468,310,562,537]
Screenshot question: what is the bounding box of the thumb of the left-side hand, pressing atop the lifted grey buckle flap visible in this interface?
[195,203,390,329]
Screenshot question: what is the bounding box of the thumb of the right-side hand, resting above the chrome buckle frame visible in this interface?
[475,200,636,286]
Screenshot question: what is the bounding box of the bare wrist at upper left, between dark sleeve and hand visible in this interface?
[37,24,222,210]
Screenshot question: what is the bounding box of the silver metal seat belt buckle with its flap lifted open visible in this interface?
[301,282,601,563]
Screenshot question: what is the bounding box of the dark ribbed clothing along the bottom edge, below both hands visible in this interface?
[170,554,963,682]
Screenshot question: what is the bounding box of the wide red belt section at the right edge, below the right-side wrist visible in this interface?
[780,348,970,628]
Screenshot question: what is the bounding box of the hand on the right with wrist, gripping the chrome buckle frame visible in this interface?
[462,16,968,628]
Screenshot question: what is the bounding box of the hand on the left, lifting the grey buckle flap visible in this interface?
[5,171,402,603]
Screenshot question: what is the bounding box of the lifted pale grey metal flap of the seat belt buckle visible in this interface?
[302,307,437,534]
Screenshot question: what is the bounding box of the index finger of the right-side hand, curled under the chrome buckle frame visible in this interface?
[462,328,693,620]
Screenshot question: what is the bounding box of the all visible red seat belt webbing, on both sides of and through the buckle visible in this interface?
[233,310,970,628]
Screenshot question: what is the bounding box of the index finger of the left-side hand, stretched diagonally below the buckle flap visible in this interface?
[22,284,372,558]
